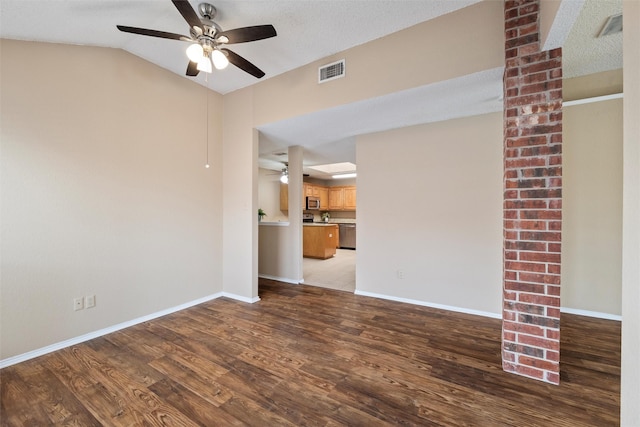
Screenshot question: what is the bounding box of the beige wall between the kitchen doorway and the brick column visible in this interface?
[356,113,502,315]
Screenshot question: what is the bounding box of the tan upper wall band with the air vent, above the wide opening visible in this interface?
[253,0,504,126]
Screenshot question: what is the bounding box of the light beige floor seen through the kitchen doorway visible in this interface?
[302,249,356,292]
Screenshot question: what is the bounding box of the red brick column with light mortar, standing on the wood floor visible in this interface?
[502,0,562,384]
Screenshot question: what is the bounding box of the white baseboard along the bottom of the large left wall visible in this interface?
[0,292,231,369]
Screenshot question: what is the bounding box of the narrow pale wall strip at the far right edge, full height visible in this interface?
[620,0,640,426]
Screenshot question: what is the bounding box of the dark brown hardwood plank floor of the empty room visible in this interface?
[0,280,620,426]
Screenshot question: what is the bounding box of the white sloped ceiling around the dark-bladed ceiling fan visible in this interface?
[0,0,480,94]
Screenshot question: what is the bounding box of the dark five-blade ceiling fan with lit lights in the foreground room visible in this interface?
[117,0,277,78]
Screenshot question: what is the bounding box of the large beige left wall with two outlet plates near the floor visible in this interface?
[0,40,222,359]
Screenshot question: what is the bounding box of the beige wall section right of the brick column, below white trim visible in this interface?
[561,99,622,315]
